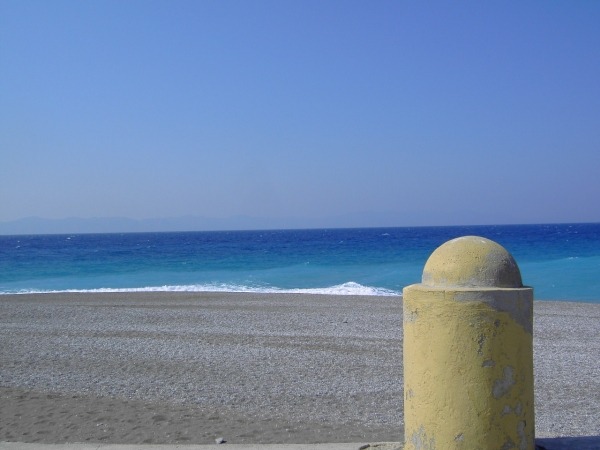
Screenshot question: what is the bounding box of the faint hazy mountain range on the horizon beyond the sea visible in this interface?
[0,213,414,235]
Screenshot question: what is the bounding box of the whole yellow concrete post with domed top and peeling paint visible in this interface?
[403,236,535,450]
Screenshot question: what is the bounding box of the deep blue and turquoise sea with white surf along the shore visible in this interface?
[0,224,600,303]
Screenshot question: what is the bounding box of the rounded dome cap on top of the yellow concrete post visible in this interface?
[422,236,523,288]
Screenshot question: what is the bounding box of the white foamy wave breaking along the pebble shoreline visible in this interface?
[0,281,401,296]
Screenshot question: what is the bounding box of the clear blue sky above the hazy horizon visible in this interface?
[0,0,600,226]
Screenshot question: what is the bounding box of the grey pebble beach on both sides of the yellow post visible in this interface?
[0,293,600,444]
